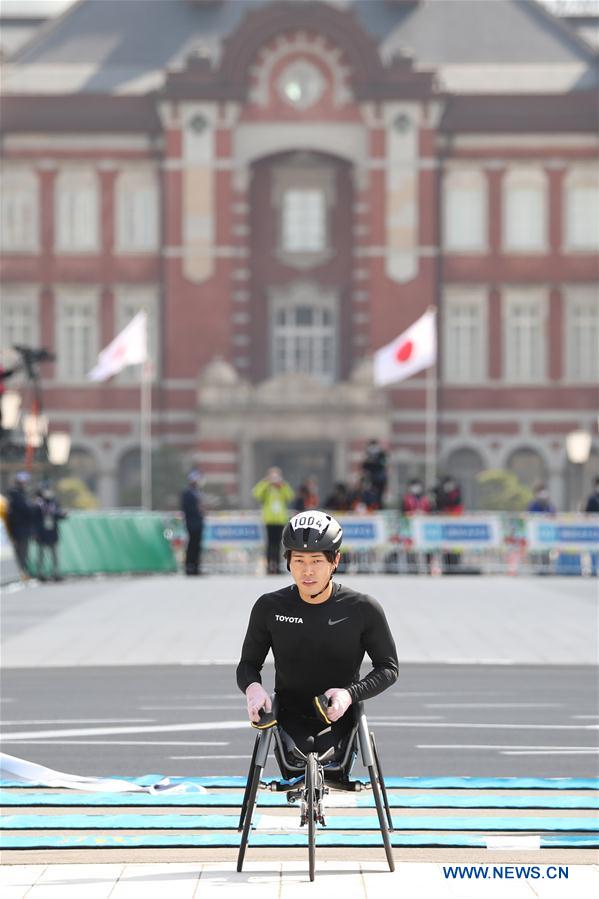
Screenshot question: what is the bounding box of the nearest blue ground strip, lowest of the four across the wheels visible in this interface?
[1,831,599,849]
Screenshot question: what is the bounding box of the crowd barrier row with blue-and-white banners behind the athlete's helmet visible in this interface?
[165,510,599,576]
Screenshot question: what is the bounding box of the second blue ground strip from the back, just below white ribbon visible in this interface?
[0,790,599,811]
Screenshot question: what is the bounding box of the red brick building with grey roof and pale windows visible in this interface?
[2,0,599,508]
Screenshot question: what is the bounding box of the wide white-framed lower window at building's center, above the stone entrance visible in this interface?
[269,285,338,384]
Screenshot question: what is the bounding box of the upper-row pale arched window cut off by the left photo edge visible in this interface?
[0,164,39,253]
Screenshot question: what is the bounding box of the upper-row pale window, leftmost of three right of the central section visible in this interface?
[443,167,489,254]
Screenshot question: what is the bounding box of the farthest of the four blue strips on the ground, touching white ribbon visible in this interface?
[0,776,599,790]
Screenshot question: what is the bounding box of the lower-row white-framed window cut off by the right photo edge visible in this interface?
[563,284,599,387]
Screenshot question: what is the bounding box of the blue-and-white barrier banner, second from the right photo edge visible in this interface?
[410,515,503,550]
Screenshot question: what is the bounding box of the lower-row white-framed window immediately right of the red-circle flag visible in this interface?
[443,285,489,384]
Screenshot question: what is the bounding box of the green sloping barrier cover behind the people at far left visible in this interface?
[29,512,177,576]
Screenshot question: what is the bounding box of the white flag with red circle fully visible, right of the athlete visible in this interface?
[374,309,437,387]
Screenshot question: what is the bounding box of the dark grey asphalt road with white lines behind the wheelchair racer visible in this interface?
[1,664,599,777]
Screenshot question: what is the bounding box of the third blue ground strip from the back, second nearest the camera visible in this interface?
[0,815,599,833]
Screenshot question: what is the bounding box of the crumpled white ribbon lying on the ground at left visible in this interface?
[0,752,208,793]
